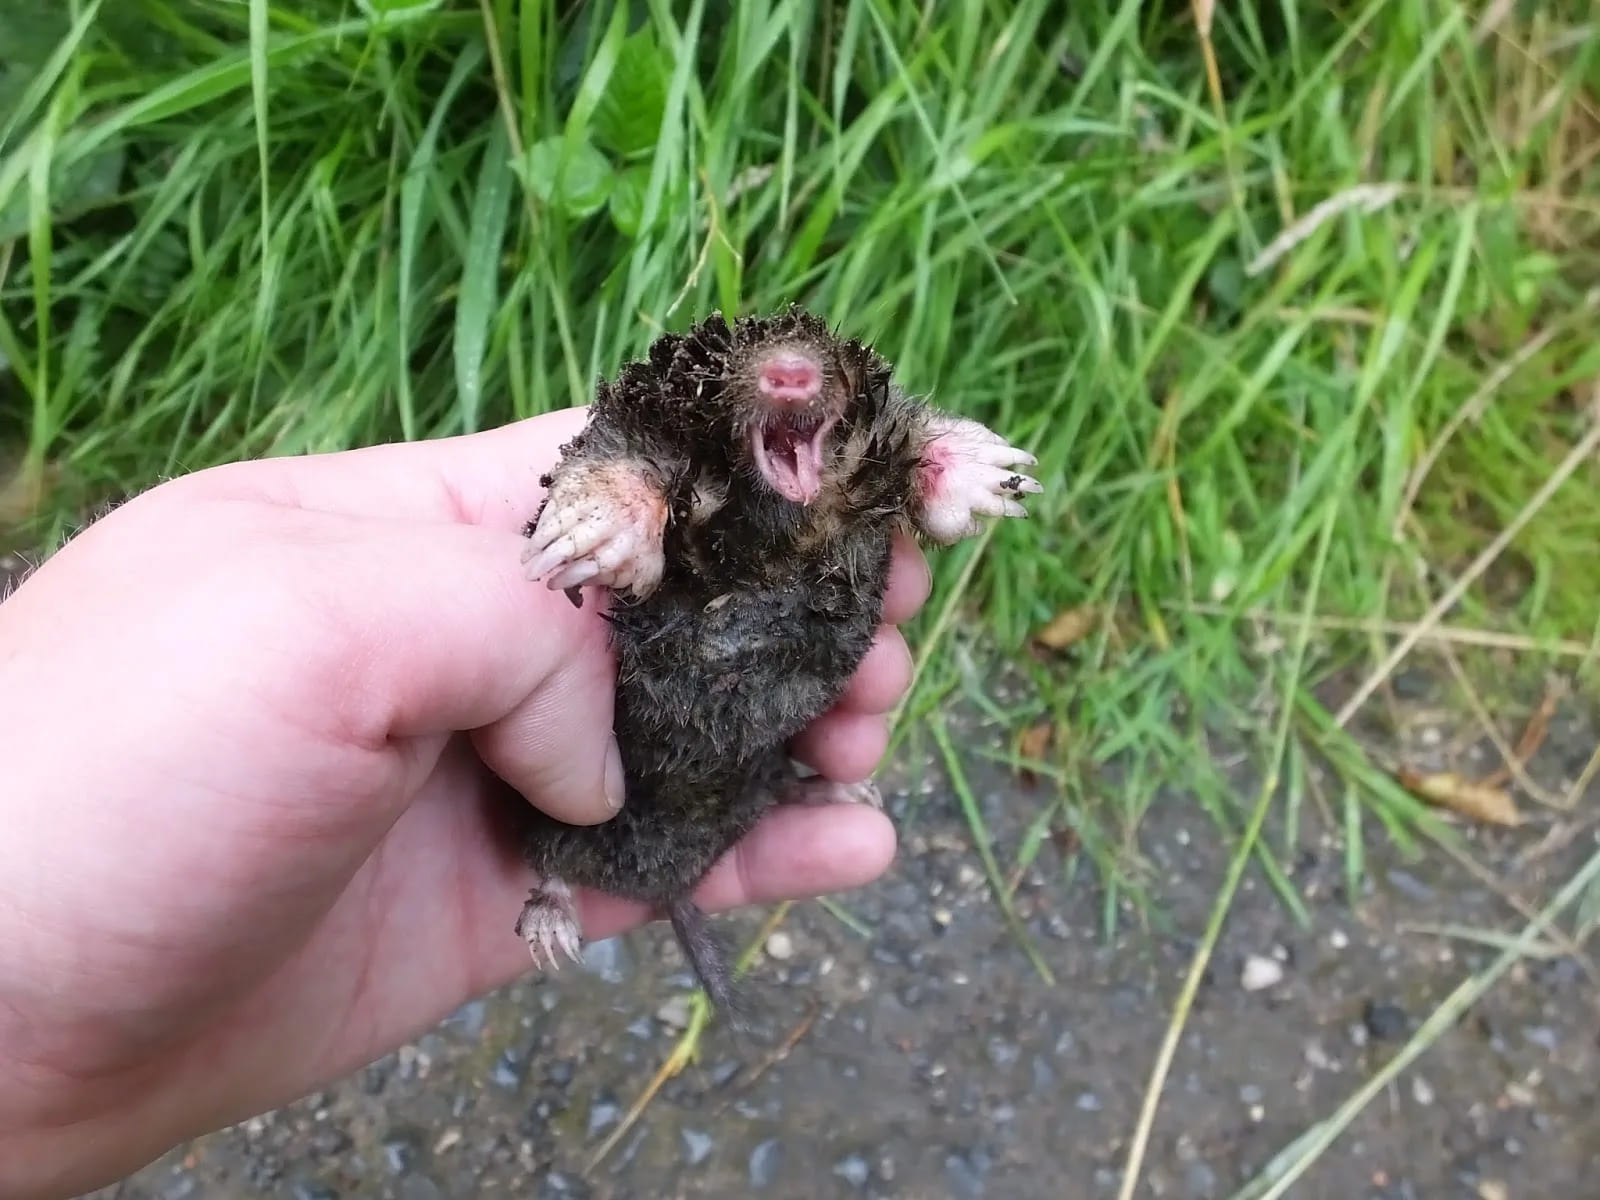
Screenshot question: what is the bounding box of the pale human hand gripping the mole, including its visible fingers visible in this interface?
[0,410,928,1197]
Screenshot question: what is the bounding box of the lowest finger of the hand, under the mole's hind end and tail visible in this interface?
[578,805,894,941]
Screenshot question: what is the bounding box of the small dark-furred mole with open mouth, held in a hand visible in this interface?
[515,306,1042,1026]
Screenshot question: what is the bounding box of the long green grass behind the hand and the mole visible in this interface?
[0,0,1600,1196]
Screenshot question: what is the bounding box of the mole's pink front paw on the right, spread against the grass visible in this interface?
[915,413,1043,544]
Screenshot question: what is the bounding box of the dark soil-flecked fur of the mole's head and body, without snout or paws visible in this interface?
[526,310,947,1013]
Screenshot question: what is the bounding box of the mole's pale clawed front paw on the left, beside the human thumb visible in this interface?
[522,462,667,597]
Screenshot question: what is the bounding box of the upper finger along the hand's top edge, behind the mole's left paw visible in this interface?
[158,408,589,531]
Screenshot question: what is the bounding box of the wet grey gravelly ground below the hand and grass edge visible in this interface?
[65,643,1600,1200]
